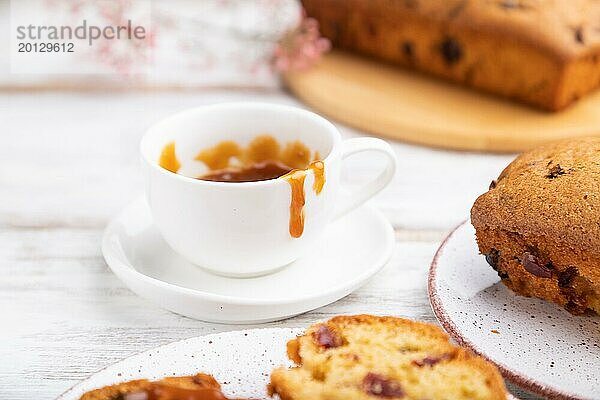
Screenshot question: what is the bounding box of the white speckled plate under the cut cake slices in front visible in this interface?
[56,328,516,400]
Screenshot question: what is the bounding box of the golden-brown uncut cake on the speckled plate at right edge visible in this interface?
[471,138,600,314]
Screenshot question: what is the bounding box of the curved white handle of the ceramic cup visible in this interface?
[333,138,397,219]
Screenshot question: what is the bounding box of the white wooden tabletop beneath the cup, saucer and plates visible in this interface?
[0,91,532,400]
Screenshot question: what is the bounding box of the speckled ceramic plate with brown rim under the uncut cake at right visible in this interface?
[429,222,600,400]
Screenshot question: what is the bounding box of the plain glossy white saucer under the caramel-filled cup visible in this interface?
[102,198,394,323]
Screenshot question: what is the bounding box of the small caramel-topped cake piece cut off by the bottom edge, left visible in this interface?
[80,374,244,400]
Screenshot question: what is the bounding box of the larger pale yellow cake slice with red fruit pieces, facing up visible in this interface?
[269,315,507,400]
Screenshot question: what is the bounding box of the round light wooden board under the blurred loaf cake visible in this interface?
[285,51,600,152]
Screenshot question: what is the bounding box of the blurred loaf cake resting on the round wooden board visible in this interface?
[303,0,600,110]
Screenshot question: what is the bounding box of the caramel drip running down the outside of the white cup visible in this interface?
[282,160,325,238]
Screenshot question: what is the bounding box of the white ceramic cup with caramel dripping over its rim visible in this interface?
[140,103,396,277]
